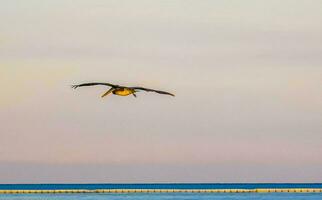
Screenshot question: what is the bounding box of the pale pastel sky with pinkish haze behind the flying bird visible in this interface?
[0,0,322,183]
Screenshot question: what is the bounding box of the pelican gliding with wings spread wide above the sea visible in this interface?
[72,83,174,98]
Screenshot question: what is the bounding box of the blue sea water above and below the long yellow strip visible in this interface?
[0,183,322,200]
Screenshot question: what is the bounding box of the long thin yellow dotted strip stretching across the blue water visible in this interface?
[0,188,322,194]
